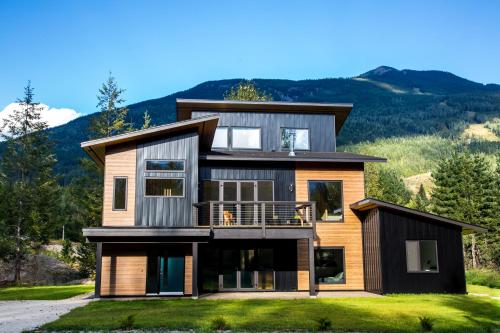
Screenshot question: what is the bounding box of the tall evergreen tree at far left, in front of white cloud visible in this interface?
[0,82,59,283]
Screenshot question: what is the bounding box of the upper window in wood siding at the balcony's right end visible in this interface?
[309,181,343,222]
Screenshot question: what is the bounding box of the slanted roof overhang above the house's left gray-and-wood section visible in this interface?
[81,116,219,167]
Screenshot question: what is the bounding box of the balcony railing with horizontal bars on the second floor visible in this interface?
[193,201,316,228]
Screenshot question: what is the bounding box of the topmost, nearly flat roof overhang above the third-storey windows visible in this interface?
[176,99,353,134]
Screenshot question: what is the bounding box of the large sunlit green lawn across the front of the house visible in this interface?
[42,294,500,332]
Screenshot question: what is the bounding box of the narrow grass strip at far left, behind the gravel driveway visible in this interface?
[0,284,94,301]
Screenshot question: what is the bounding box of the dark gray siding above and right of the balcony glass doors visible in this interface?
[199,161,295,201]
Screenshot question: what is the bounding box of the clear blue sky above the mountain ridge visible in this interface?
[0,0,500,113]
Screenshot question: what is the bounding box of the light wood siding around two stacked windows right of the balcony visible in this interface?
[295,163,365,291]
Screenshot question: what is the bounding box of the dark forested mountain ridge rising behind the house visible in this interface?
[44,66,500,180]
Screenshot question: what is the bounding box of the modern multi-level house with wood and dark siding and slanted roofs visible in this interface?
[82,100,485,297]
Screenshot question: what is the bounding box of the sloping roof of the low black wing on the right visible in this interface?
[349,198,488,233]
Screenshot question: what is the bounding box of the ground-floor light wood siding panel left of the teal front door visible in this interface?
[101,246,147,296]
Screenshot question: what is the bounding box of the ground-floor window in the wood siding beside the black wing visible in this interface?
[314,248,345,284]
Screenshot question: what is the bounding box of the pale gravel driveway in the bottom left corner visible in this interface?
[0,295,92,333]
